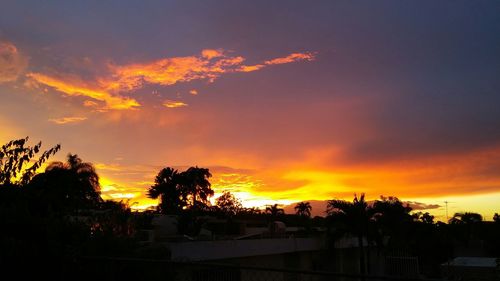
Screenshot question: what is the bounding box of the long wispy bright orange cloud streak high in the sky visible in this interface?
[25,48,315,109]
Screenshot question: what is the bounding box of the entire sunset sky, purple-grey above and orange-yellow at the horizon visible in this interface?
[0,0,500,220]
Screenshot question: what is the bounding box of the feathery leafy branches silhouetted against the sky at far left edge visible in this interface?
[0,137,61,186]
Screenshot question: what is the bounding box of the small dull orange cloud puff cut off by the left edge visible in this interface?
[0,42,28,84]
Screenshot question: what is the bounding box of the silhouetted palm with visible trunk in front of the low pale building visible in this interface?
[327,193,372,280]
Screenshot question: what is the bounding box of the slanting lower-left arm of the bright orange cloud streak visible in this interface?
[27,73,140,109]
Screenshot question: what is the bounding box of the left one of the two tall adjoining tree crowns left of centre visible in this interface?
[148,167,186,214]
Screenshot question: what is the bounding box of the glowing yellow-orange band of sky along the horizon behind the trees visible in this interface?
[97,142,500,221]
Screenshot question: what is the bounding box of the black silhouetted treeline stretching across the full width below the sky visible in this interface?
[0,138,500,274]
